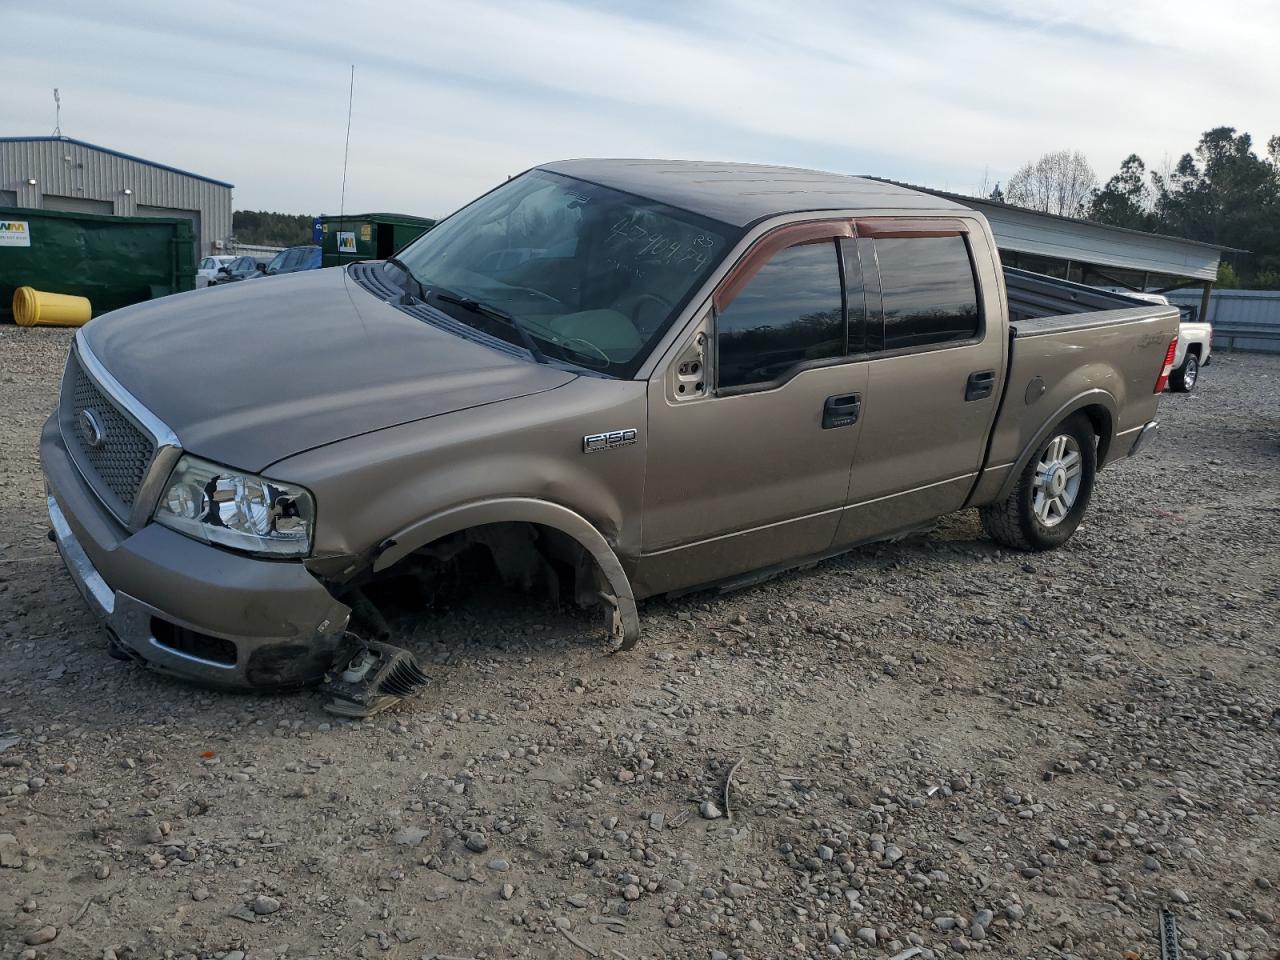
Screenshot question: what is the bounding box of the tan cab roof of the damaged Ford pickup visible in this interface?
[538,160,969,227]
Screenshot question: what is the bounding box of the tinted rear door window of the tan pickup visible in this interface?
[876,237,979,351]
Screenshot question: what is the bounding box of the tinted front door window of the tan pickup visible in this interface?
[716,241,845,387]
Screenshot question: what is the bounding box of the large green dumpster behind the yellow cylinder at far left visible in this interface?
[0,206,196,321]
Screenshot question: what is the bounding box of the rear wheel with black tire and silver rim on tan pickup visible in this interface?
[978,413,1098,550]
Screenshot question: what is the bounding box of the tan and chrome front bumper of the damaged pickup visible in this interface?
[40,417,351,690]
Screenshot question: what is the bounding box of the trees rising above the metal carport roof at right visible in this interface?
[991,127,1280,289]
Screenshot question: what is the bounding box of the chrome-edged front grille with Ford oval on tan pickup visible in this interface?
[58,337,179,529]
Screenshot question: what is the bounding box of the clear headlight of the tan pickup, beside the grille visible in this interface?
[155,456,316,557]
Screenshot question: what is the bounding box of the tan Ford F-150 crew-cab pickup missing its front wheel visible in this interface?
[41,160,1178,689]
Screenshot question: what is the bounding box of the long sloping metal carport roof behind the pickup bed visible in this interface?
[870,184,1234,282]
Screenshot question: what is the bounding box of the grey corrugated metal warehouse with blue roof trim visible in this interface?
[0,137,232,259]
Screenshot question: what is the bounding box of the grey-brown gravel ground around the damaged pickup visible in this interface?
[0,328,1280,960]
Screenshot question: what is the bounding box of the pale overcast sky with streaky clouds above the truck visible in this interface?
[0,0,1280,216]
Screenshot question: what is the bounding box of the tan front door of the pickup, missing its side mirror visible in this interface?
[635,221,867,595]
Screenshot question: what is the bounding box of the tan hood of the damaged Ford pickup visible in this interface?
[81,269,575,471]
